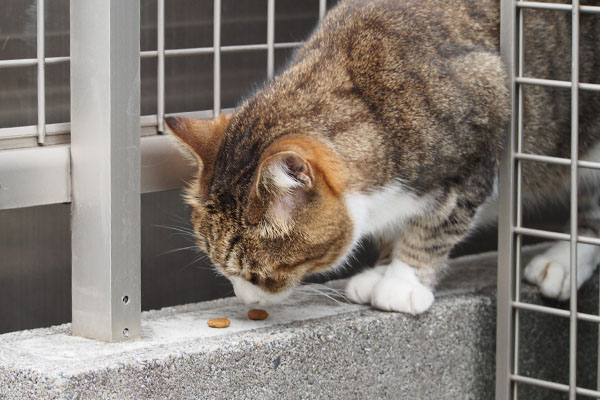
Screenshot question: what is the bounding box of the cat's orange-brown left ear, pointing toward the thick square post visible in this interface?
[165,114,231,169]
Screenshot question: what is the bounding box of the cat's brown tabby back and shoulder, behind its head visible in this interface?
[237,0,507,188]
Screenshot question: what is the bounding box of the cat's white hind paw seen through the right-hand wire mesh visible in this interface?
[524,242,600,300]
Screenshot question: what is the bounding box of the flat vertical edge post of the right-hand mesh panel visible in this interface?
[496,0,517,400]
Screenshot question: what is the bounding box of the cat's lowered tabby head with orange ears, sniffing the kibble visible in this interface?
[165,115,353,304]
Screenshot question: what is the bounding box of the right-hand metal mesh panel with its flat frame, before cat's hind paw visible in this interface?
[496,0,600,399]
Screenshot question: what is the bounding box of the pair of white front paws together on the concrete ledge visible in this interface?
[346,261,434,315]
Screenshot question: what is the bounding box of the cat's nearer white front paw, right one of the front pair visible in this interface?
[371,261,434,315]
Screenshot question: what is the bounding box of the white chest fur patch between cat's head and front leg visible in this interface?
[346,184,432,236]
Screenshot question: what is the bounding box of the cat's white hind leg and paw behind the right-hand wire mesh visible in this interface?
[524,192,600,300]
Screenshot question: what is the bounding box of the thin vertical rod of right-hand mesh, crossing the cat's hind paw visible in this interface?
[569,0,579,400]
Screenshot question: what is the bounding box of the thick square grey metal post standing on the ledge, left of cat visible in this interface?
[71,0,141,341]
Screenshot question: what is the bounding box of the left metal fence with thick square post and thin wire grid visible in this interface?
[0,0,326,341]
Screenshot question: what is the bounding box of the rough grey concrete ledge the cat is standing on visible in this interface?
[0,244,597,399]
